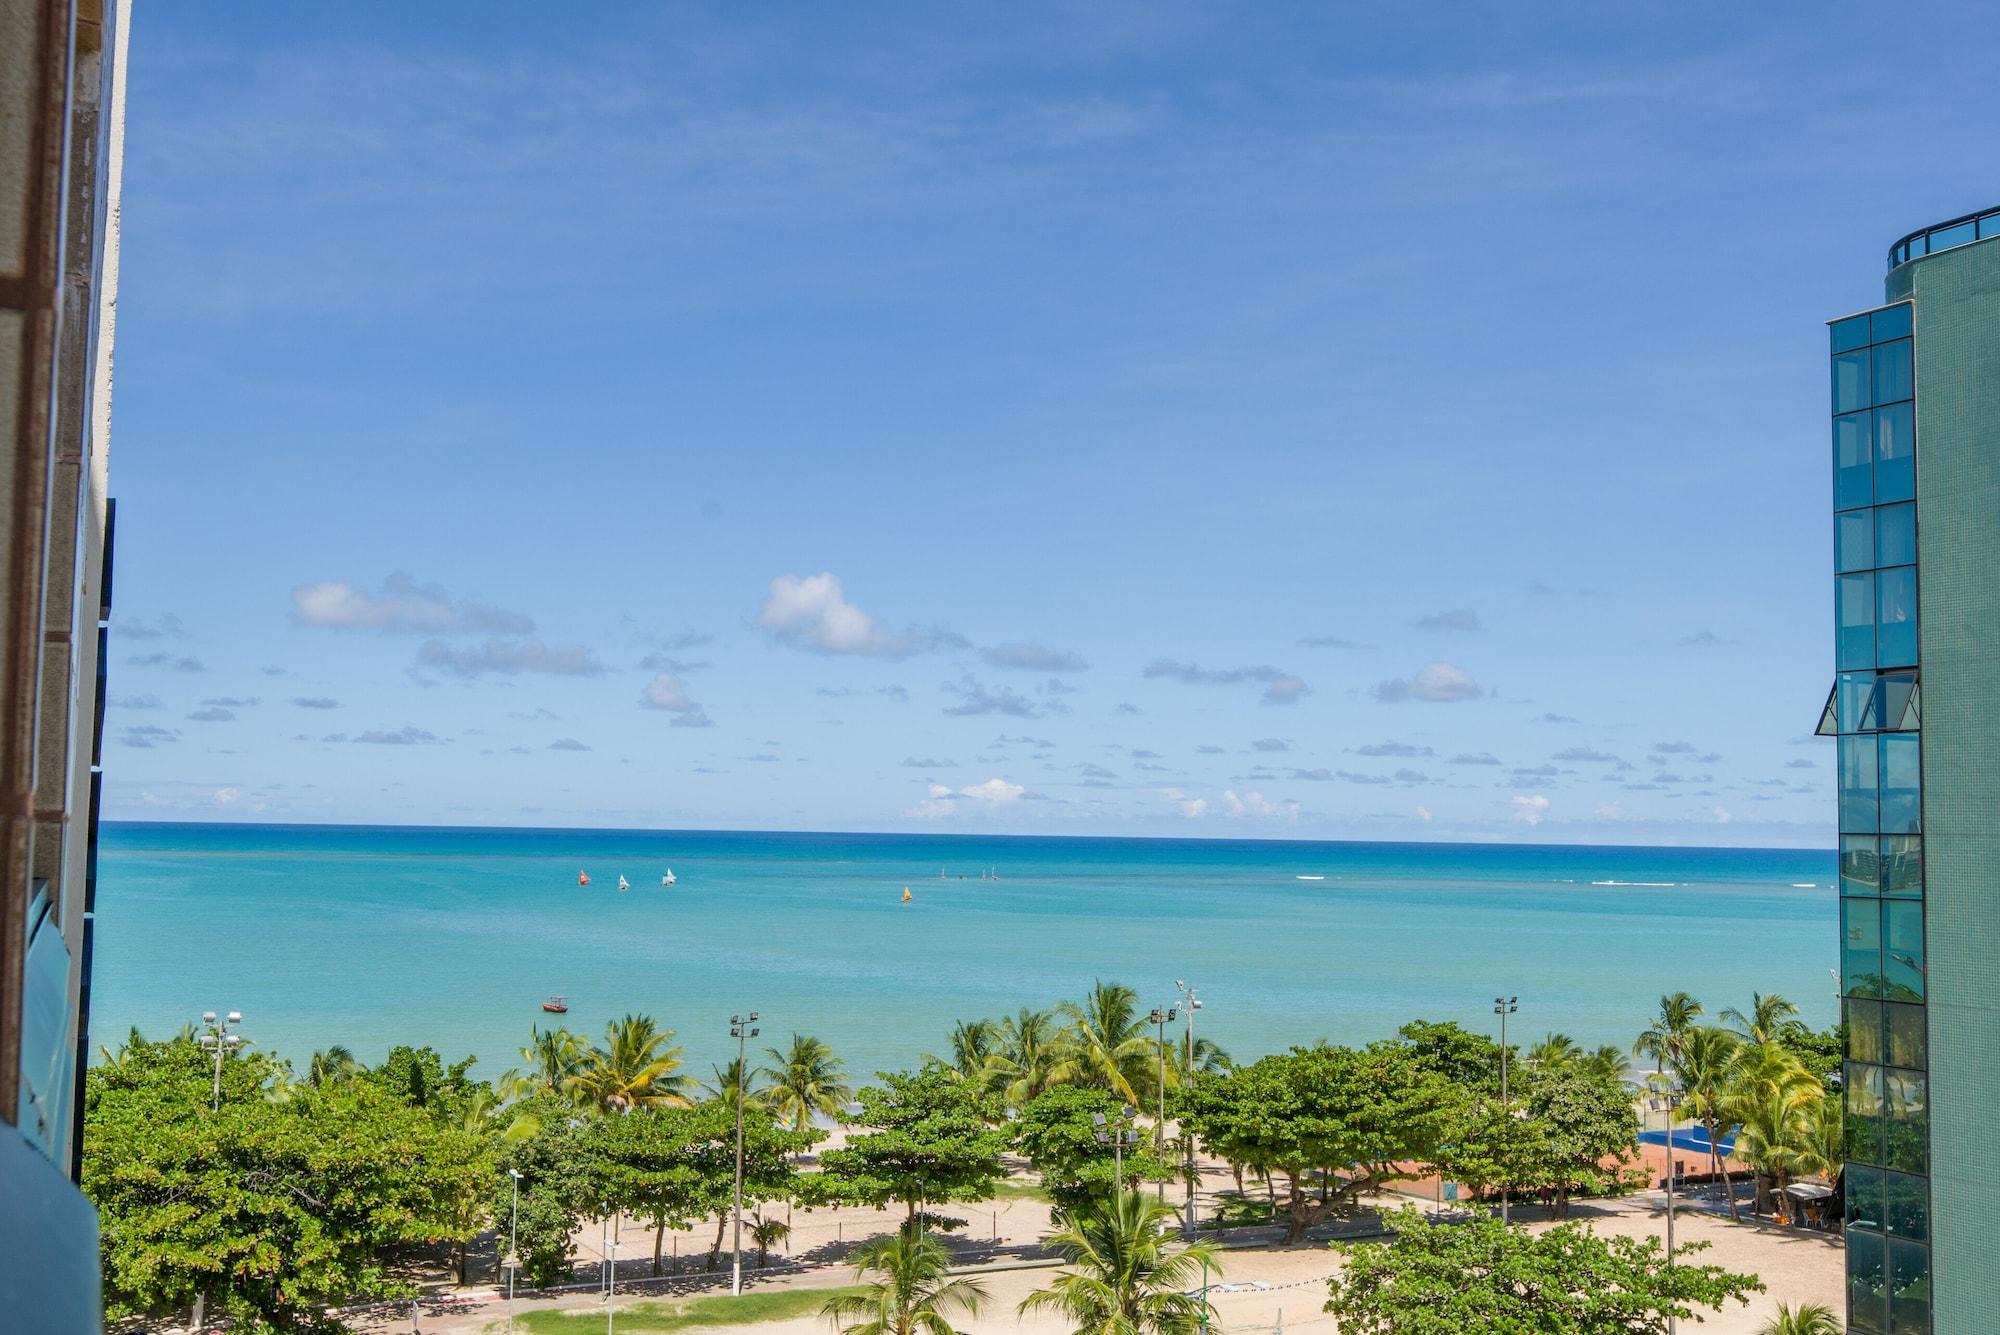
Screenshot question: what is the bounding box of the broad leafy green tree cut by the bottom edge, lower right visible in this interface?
[1326,1209,1764,1335]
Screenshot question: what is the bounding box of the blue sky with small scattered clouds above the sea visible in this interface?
[106,4,2000,845]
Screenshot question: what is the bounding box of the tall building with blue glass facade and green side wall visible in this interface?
[1820,210,2000,1335]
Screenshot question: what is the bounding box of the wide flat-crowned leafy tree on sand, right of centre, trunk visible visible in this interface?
[1180,1043,1462,1243]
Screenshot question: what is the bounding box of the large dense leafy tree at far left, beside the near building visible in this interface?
[84,1041,494,1329]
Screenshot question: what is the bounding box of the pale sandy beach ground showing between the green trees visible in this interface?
[332,1147,1842,1335]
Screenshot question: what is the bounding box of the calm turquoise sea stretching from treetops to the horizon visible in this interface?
[92,823,1838,1077]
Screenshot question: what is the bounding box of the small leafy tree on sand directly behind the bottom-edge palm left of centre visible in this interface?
[814,1065,1006,1217]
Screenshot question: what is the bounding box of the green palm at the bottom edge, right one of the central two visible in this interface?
[1020,1191,1220,1335]
